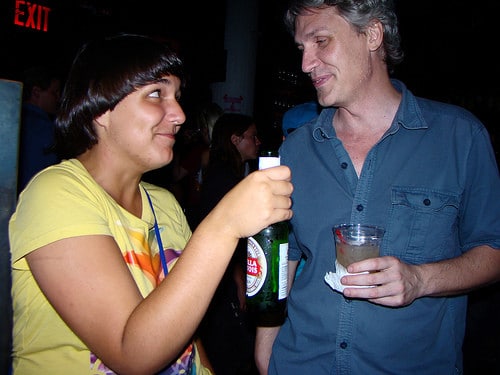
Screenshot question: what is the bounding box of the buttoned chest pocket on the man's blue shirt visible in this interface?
[384,186,460,264]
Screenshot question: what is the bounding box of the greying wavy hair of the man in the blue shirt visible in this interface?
[284,0,404,71]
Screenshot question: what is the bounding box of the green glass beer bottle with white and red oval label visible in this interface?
[246,151,289,327]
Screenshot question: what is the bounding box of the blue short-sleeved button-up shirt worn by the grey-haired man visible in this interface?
[269,80,500,375]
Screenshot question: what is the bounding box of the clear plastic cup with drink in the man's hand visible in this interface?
[333,224,385,268]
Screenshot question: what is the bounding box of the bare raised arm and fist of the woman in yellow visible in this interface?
[27,167,292,374]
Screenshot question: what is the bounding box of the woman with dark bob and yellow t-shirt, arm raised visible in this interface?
[9,35,292,374]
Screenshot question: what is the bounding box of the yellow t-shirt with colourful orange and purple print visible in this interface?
[9,159,209,375]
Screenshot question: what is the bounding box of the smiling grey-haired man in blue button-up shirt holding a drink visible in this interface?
[256,0,500,375]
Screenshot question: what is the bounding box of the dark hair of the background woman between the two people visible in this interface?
[209,113,255,177]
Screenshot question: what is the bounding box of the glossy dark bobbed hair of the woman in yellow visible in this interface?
[55,34,185,159]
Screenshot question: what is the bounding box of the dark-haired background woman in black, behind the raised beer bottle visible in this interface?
[200,113,261,375]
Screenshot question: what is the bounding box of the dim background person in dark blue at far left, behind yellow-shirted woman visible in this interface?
[18,66,61,192]
